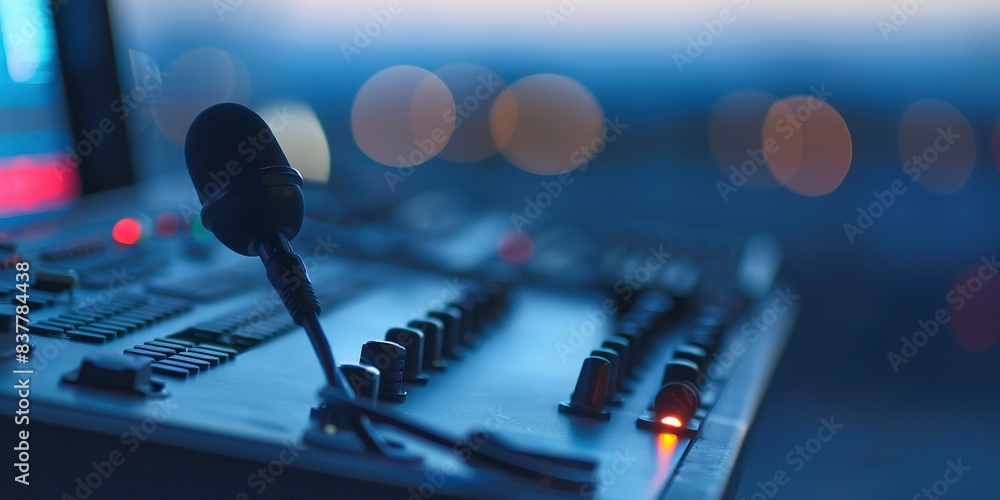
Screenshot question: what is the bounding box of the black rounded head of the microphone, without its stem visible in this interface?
[184,103,304,256]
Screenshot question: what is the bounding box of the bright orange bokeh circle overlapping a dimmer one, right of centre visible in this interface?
[761,95,853,196]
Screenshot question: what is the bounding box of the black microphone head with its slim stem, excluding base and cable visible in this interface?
[184,103,354,399]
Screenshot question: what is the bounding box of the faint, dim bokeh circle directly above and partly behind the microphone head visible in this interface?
[153,48,250,145]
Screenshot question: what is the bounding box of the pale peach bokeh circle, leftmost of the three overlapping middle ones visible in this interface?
[351,66,455,168]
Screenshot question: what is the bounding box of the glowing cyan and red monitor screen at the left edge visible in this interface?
[0,0,80,217]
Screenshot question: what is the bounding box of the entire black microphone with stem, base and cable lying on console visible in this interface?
[184,103,593,487]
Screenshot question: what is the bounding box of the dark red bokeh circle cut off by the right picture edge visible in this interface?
[948,257,1000,352]
